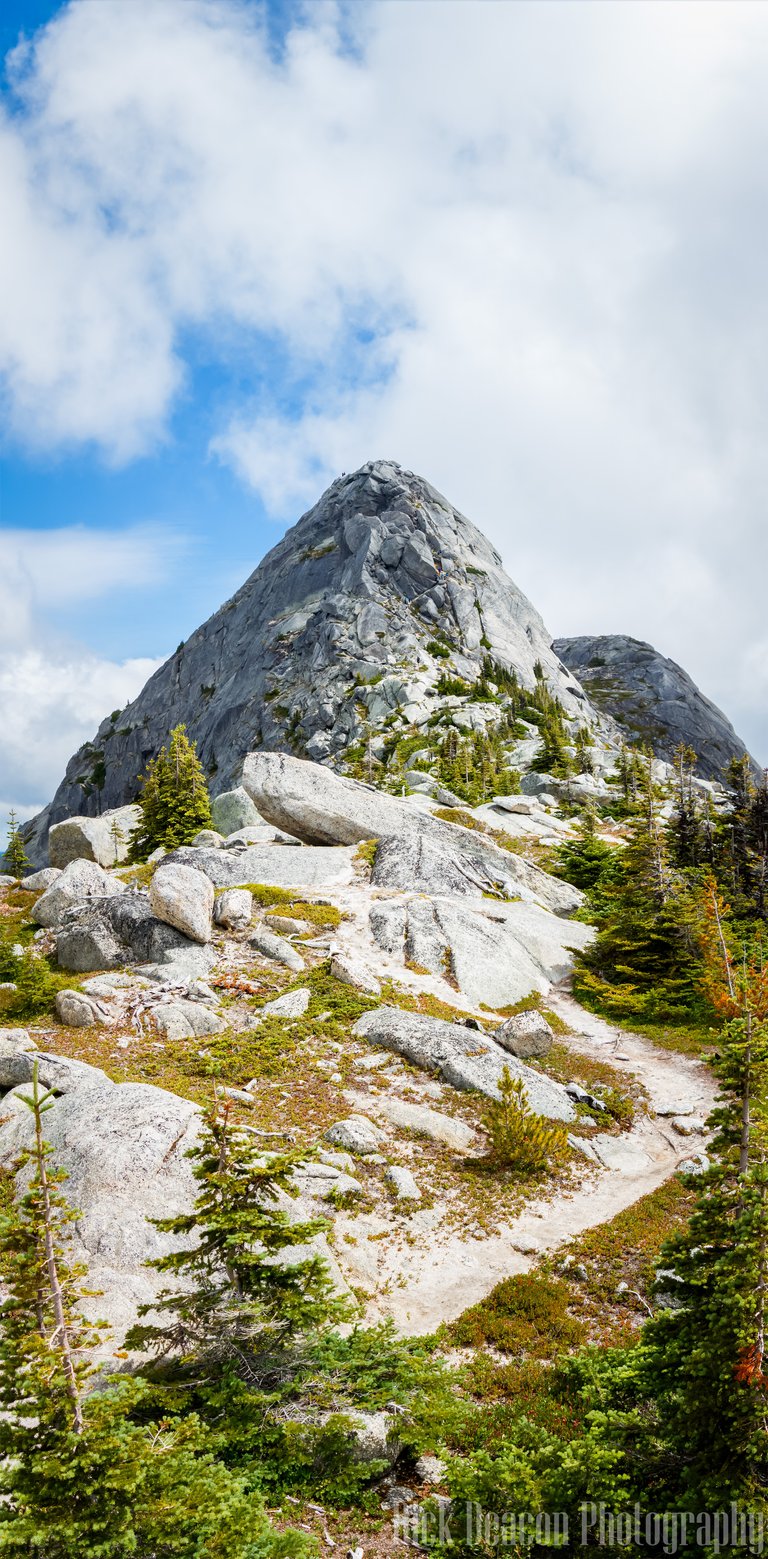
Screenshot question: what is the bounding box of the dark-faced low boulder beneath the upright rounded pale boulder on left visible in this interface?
[51,889,196,974]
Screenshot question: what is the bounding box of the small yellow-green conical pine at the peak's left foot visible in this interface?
[131,725,210,861]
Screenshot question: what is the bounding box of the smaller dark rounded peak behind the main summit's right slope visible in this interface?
[551,633,757,780]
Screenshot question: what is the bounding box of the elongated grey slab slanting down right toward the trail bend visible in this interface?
[352,1007,576,1121]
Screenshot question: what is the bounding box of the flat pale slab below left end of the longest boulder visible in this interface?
[165,845,355,889]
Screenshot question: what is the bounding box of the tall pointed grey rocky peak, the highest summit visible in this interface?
[25,460,597,845]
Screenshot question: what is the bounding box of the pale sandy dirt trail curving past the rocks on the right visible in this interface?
[336,990,715,1333]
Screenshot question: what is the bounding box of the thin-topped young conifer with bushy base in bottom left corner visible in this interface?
[0,1071,307,1559]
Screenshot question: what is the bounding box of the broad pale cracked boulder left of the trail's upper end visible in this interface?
[369,895,594,1007]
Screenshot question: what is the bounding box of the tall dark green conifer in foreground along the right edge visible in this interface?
[642,879,768,1514]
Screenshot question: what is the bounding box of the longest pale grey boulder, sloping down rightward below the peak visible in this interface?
[243,753,583,915]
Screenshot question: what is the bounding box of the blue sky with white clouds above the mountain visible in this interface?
[0,0,768,814]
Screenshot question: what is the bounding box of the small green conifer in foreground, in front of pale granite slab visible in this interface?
[128,1105,347,1383]
